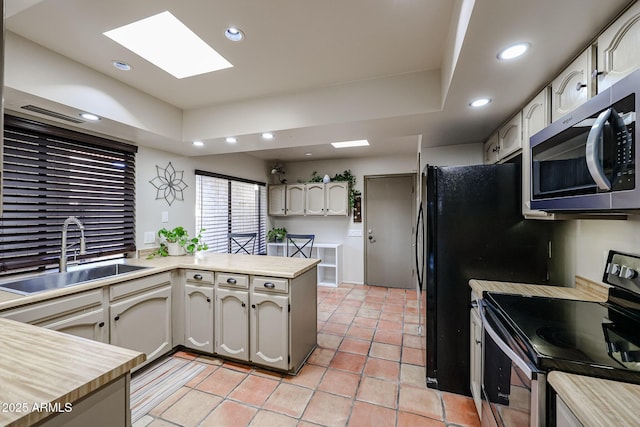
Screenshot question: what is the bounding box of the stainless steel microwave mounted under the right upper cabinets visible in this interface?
[530,70,640,213]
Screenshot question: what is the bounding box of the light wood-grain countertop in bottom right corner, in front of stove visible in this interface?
[547,371,640,427]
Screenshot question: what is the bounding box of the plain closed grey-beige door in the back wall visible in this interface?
[364,175,416,289]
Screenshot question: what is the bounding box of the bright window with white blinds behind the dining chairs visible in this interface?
[196,170,267,254]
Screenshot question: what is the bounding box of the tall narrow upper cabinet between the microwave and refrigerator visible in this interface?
[522,88,553,219]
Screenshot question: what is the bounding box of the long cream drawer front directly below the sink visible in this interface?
[0,289,102,323]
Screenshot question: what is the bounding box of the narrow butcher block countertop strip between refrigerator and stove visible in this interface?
[469,276,609,302]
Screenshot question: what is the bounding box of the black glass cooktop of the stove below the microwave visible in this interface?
[486,293,640,383]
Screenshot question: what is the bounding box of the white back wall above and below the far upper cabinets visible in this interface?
[270,155,417,284]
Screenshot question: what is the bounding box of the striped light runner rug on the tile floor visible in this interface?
[130,358,205,423]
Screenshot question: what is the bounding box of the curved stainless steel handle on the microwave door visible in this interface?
[585,108,629,191]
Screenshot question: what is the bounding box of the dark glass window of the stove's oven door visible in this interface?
[482,332,532,427]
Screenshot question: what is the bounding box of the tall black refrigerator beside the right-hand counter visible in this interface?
[421,161,552,396]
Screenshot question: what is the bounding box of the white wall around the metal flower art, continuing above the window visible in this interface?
[136,147,267,249]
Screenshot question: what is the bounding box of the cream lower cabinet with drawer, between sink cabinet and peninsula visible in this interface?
[109,274,173,368]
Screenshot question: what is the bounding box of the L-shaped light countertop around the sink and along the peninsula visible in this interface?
[0,253,320,310]
